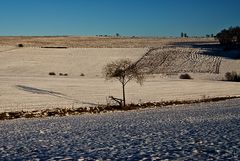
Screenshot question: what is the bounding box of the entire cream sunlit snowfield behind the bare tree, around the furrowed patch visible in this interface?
[0,46,240,112]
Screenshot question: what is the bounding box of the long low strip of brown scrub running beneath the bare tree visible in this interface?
[0,96,239,120]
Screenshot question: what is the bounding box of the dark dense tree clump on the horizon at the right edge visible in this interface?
[216,26,240,49]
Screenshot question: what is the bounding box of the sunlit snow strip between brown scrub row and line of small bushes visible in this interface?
[0,77,240,112]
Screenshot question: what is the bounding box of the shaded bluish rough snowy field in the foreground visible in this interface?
[0,99,240,160]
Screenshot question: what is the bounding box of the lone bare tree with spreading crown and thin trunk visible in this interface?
[103,59,144,107]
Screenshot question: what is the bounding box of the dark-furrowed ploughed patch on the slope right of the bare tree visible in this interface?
[137,47,222,74]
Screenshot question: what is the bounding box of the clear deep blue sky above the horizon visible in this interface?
[0,0,240,36]
